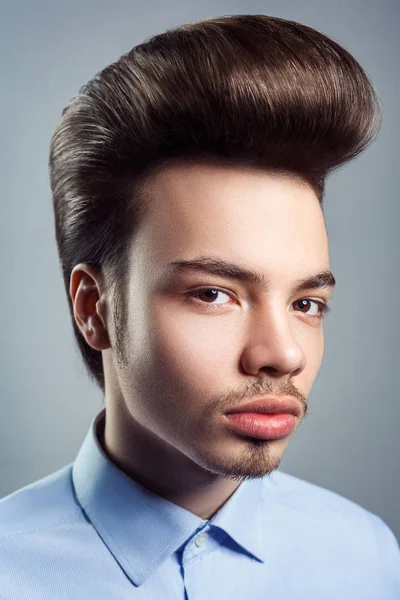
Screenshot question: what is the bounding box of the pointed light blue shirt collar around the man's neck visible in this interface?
[72,409,270,585]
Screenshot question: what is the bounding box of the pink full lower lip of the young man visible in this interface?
[225,413,296,440]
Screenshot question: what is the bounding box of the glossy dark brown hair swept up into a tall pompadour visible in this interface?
[49,15,381,392]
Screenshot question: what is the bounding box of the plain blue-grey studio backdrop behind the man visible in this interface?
[0,0,400,538]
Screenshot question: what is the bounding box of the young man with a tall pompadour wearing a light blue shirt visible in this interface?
[0,15,400,600]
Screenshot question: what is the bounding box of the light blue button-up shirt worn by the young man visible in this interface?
[0,409,400,600]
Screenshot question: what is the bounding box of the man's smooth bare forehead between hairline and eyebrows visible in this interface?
[133,164,329,270]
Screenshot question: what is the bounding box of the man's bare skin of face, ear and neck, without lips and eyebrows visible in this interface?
[70,163,332,519]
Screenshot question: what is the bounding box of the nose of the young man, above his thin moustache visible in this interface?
[241,304,306,376]
